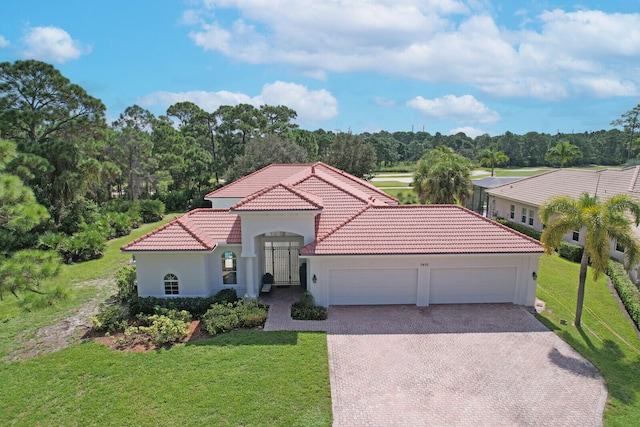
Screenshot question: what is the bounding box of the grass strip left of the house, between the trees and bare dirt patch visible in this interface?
[0,214,180,359]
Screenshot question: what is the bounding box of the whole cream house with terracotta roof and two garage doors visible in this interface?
[122,162,543,306]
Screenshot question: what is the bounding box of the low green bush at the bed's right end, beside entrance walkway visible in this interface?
[202,299,267,335]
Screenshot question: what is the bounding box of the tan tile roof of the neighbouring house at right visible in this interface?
[487,166,640,206]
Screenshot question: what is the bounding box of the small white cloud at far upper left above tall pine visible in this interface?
[21,27,91,64]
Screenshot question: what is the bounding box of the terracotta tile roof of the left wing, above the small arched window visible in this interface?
[120,209,242,251]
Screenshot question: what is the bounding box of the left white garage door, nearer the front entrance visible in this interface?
[329,268,418,305]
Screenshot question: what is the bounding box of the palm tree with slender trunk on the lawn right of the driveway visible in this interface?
[539,193,640,328]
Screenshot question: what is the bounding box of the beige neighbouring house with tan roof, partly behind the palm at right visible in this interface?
[486,166,640,280]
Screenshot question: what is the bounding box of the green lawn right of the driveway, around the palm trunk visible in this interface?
[538,256,640,426]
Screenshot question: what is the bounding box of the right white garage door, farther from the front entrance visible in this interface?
[429,267,516,304]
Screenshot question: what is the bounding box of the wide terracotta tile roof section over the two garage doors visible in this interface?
[300,205,543,255]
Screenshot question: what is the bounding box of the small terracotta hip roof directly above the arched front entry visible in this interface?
[231,184,322,212]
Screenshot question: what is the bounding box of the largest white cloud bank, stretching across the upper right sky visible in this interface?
[185,0,640,100]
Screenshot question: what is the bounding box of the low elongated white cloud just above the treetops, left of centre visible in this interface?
[136,81,338,124]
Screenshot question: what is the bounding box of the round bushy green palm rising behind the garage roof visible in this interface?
[413,146,472,204]
